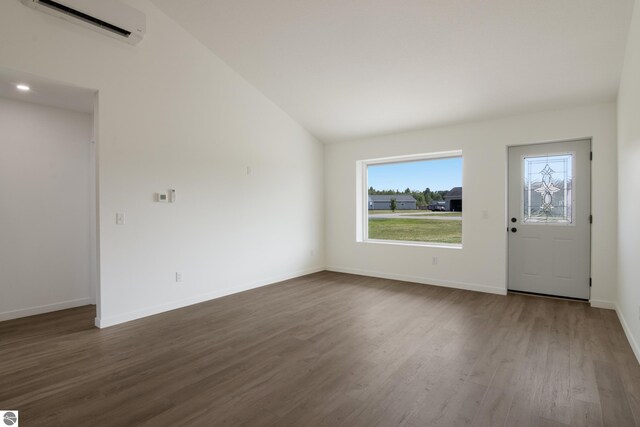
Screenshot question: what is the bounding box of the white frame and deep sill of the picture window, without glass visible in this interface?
[356,150,464,249]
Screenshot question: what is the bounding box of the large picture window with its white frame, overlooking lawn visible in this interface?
[358,151,463,247]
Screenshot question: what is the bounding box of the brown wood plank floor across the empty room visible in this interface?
[0,272,640,427]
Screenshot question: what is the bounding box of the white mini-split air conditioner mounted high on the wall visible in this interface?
[20,0,147,45]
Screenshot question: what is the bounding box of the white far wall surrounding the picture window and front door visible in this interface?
[325,104,617,308]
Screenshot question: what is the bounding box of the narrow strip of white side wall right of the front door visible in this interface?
[618,2,640,360]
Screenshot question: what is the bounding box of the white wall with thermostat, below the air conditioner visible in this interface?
[0,0,324,326]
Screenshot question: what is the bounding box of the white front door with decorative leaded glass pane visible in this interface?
[507,140,591,299]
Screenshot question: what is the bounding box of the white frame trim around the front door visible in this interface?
[504,136,593,301]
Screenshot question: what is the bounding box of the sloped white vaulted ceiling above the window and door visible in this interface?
[152,0,633,142]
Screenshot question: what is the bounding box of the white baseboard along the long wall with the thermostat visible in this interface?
[95,267,324,328]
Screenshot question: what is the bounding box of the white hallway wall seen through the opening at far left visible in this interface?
[0,98,95,320]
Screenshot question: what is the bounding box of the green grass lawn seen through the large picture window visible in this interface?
[369,218,462,244]
